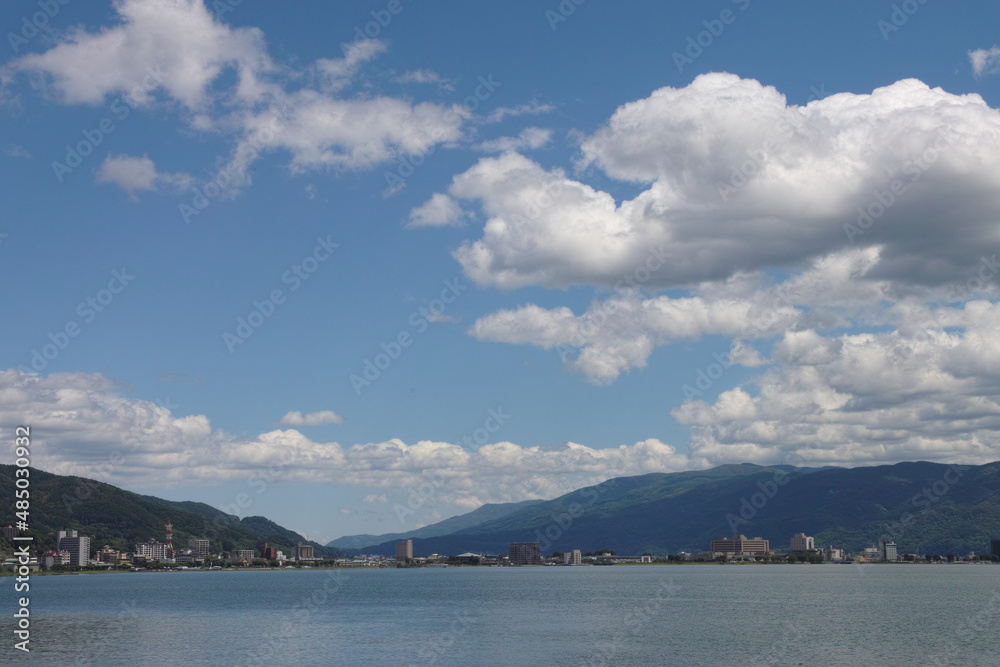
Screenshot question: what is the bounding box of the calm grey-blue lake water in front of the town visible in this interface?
[0,565,1000,665]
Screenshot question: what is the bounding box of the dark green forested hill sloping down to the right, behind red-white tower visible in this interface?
[0,465,340,556]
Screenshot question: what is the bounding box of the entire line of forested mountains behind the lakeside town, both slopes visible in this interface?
[7,462,1000,557]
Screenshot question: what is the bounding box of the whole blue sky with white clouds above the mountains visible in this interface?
[0,0,1000,541]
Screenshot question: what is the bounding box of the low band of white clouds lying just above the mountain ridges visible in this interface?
[0,366,1000,508]
